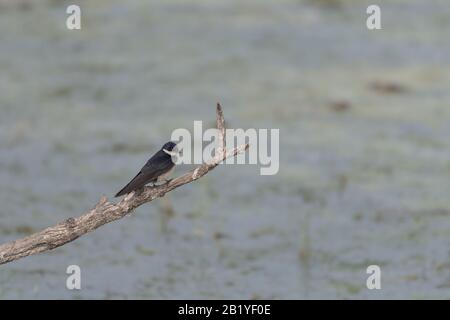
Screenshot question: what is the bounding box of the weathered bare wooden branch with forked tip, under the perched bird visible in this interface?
[0,104,249,264]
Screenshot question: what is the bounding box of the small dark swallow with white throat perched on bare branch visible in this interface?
[115,141,177,197]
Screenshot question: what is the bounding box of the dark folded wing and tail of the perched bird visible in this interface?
[115,151,174,197]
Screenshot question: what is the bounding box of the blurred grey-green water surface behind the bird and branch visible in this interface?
[0,0,450,299]
